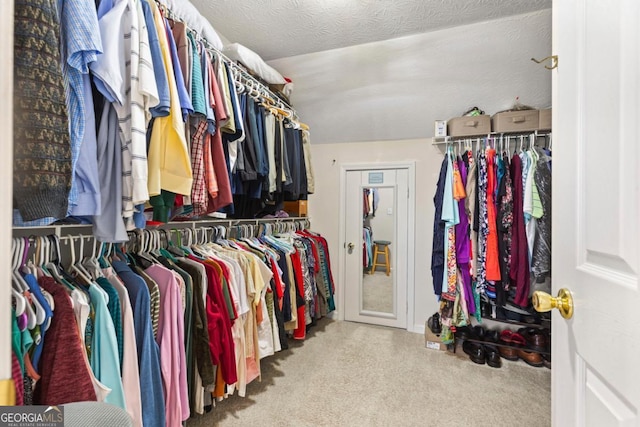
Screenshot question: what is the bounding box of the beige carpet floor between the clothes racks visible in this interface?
[187,320,551,427]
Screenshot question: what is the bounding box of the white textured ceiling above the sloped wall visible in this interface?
[191,0,552,60]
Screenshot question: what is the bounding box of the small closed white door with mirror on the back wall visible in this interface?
[344,169,409,329]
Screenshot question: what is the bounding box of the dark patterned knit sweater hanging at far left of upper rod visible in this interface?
[13,0,73,225]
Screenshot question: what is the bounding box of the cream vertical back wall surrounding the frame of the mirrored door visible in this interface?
[309,138,443,332]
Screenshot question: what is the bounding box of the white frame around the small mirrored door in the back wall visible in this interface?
[337,160,416,332]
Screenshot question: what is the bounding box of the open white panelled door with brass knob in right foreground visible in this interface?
[552,0,640,427]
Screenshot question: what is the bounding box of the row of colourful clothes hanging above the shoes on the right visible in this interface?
[432,137,551,320]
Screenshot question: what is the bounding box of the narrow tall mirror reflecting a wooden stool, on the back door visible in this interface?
[361,187,396,314]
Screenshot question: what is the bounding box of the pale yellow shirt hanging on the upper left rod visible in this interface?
[147,1,193,196]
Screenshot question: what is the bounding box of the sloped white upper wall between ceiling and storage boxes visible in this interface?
[269,9,551,144]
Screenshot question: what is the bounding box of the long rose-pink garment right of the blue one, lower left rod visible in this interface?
[145,264,190,427]
